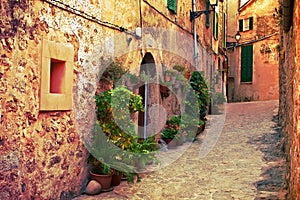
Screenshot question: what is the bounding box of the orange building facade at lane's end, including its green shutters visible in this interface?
[228,0,279,101]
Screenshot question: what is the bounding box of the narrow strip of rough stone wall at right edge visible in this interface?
[279,0,300,199]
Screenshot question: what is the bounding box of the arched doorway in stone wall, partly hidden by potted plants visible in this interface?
[138,53,160,139]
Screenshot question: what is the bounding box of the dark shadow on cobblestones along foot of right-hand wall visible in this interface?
[249,116,286,200]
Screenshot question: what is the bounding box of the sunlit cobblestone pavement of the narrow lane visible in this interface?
[75,101,285,200]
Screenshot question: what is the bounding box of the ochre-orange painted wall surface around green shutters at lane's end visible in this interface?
[228,0,279,101]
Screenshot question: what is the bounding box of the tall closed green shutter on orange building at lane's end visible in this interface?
[241,45,253,82]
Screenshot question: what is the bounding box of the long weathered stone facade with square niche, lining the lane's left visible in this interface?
[0,0,226,199]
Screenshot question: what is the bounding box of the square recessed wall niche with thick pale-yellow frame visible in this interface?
[40,40,74,111]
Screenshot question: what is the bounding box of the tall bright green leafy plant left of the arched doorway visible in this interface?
[93,61,157,185]
